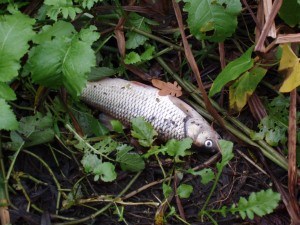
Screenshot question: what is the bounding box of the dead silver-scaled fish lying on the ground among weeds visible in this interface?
[81,78,220,149]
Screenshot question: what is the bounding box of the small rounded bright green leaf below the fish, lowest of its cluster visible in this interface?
[93,162,117,182]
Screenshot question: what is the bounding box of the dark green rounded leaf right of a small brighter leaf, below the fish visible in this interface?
[116,145,145,172]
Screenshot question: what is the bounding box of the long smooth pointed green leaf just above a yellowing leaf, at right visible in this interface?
[209,47,254,97]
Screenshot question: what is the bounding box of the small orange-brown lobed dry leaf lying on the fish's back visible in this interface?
[151,79,182,97]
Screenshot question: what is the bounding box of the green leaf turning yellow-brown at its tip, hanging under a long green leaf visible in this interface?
[229,67,267,111]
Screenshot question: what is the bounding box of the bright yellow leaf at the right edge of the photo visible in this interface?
[278,44,300,92]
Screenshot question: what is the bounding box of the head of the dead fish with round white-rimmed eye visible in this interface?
[185,118,221,150]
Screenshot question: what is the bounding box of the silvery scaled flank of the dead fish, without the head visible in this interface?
[81,78,188,140]
